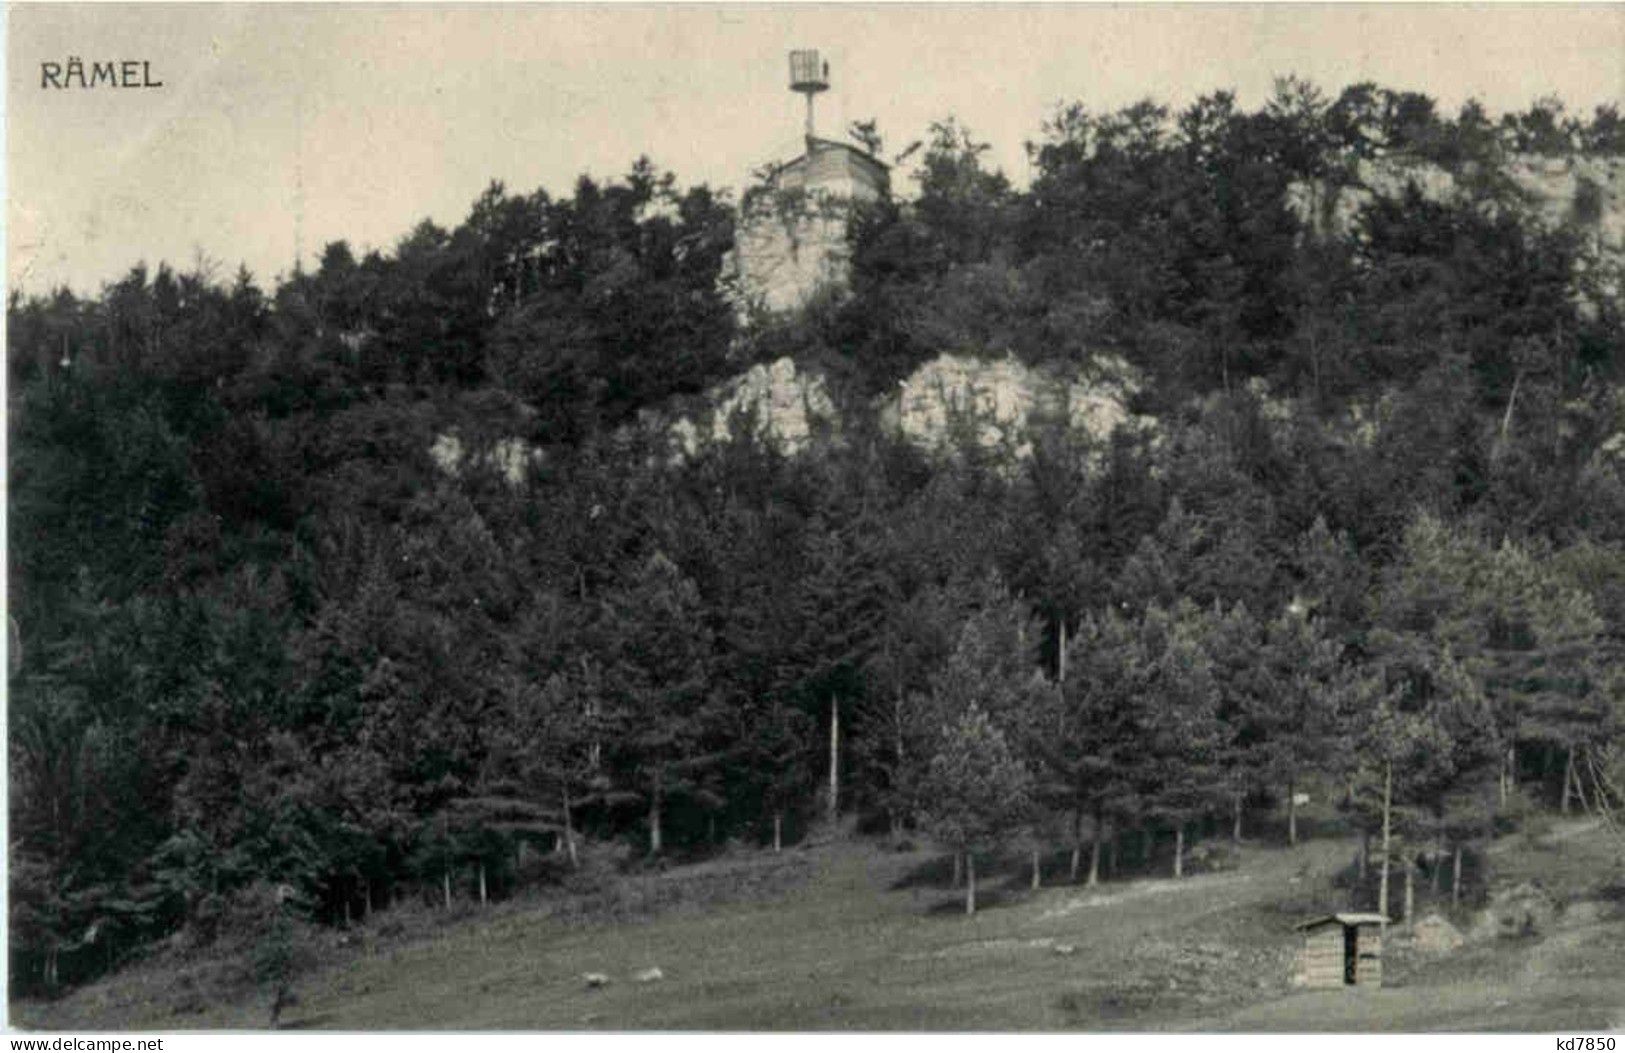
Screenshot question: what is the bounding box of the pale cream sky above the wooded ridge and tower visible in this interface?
[5,3,1625,294]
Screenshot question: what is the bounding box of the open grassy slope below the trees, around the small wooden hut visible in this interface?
[18,819,1625,1030]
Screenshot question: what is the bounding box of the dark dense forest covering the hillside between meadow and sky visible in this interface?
[7,81,1625,991]
